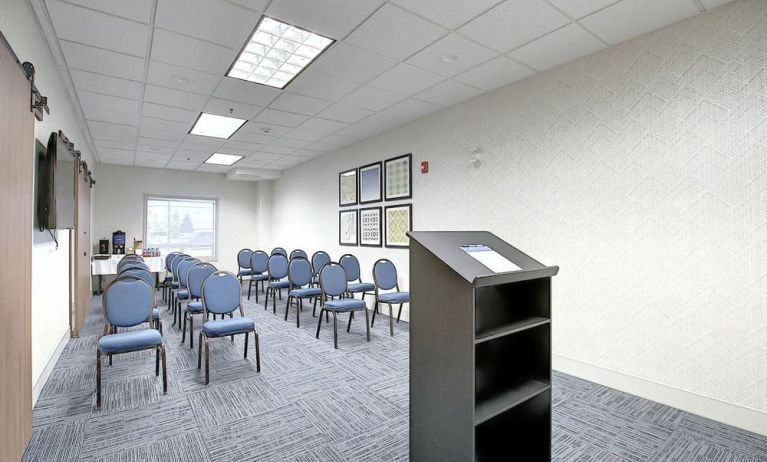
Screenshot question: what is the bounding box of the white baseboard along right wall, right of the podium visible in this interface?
[552,355,767,436]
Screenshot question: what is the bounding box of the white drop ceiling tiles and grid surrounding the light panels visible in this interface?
[33,0,727,172]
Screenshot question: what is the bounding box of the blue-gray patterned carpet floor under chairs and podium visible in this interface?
[23,288,767,462]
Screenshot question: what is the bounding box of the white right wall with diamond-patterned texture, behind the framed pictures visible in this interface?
[270,0,767,426]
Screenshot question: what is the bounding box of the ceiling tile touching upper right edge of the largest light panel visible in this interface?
[311,43,397,83]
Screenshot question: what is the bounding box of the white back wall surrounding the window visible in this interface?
[93,164,260,273]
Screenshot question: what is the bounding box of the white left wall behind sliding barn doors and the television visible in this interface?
[0,0,98,399]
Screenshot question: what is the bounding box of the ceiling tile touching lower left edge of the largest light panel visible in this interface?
[151,29,234,75]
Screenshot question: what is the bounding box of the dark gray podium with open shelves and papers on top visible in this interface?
[409,231,559,462]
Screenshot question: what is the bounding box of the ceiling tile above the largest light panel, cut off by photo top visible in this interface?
[266,0,382,40]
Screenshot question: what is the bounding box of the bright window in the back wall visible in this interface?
[144,196,218,260]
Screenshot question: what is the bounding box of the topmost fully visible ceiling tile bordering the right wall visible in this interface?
[509,24,605,71]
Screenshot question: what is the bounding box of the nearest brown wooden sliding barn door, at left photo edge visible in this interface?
[0,34,35,461]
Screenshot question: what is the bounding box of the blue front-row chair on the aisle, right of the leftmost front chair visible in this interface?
[197,271,261,385]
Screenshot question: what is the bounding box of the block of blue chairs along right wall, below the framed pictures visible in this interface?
[237,247,410,347]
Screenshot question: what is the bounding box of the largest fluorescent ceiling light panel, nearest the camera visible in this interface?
[226,16,335,89]
